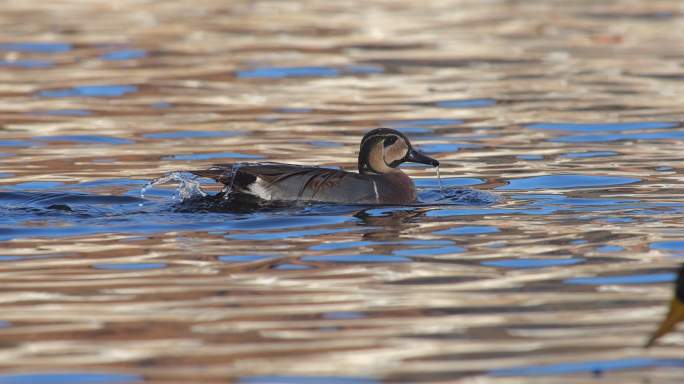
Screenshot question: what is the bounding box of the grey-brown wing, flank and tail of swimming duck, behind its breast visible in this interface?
[191,163,379,204]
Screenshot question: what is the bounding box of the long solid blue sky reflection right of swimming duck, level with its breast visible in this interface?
[496,175,641,190]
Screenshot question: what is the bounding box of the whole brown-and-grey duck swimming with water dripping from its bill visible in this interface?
[190,128,439,205]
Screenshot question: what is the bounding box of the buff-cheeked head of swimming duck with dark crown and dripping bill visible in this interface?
[359,128,439,174]
